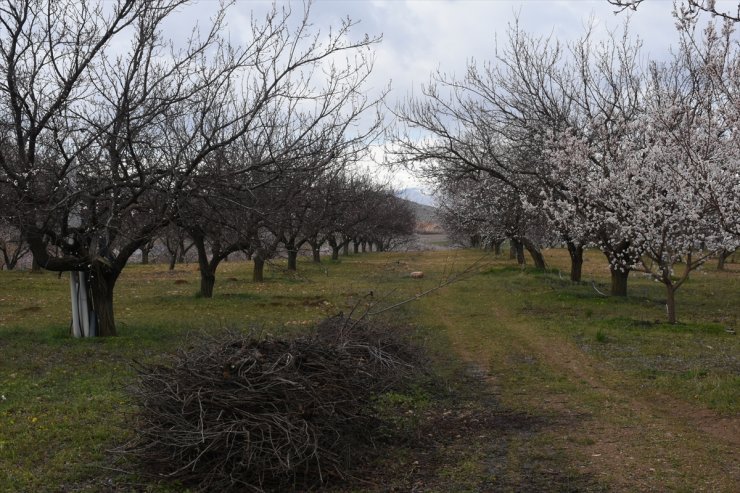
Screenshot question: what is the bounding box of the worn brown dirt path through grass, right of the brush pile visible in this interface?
[430,302,740,492]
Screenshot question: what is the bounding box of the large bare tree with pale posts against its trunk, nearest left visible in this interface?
[0,0,382,335]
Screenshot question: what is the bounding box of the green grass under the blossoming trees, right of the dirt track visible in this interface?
[466,252,740,414]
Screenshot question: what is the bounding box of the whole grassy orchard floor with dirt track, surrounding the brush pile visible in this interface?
[0,250,740,492]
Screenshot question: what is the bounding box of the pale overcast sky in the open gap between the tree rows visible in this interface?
[172,0,737,190]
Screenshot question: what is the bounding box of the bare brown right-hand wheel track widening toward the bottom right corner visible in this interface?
[519,320,740,492]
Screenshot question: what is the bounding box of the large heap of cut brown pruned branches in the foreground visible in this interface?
[124,317,422,491]
